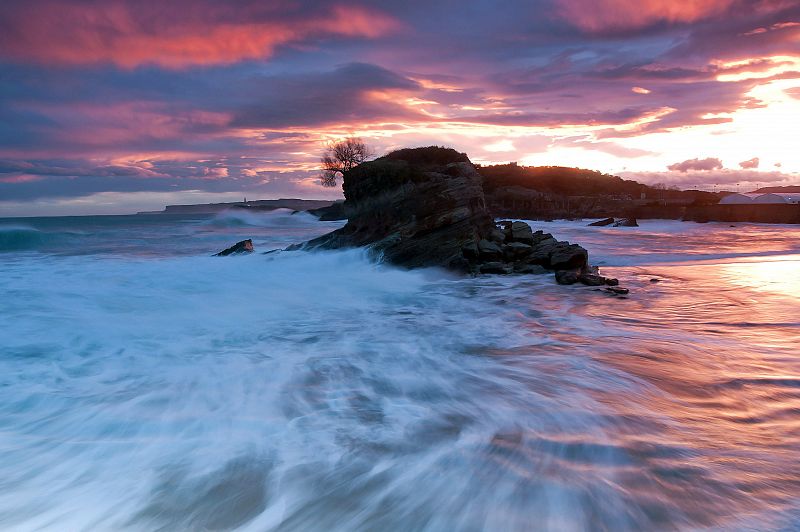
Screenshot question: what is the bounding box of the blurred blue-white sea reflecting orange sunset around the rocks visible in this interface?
[0,210,800,531]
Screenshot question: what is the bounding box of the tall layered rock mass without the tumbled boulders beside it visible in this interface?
[306,148,495,270]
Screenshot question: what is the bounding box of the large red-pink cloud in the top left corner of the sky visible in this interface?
[0,0,398,69]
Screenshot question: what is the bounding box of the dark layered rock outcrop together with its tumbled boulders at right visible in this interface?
[304,147,620,284]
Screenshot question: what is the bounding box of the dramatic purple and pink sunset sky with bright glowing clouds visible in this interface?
[0,0,800,216]
